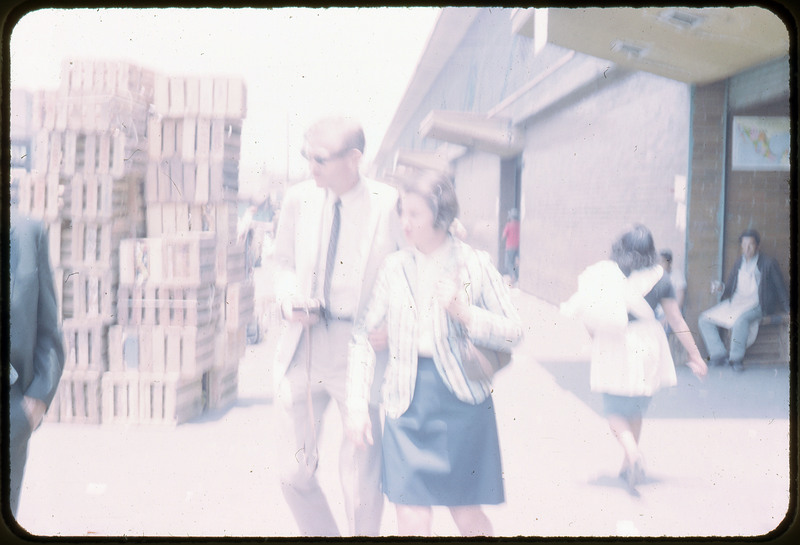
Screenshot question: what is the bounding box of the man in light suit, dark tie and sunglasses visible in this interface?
[273,118,402,536]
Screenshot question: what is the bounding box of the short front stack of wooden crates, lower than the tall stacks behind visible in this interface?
[102,232,219,423]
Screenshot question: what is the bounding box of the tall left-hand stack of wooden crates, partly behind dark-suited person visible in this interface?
[18,61,154,423]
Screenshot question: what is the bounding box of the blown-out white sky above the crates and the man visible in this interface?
[10,7,440,193]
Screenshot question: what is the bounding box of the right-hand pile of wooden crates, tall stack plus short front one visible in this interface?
[103,70,252,422]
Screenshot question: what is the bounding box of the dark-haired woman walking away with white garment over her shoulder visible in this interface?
[561,225,708,493]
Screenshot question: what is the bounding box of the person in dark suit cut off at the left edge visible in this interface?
[8,208,64,517]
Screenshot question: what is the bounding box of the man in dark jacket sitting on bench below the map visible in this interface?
[698,229,789,371]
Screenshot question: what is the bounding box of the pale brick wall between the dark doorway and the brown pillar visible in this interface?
[520,68,689,303]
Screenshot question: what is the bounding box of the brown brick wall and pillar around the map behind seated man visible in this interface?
[684,78,791,351]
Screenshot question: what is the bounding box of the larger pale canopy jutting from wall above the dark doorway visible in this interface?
[420,110,523,157]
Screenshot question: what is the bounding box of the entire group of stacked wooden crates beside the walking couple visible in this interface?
[14,60,253,424]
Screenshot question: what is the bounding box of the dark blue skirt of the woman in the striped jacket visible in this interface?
[383,358,505,506]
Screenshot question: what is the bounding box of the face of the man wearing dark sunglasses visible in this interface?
[303,131,359,193]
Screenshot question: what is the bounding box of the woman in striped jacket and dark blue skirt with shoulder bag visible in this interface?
[347,171,522,536]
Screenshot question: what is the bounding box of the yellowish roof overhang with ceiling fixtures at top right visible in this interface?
[511,6,789,85]
